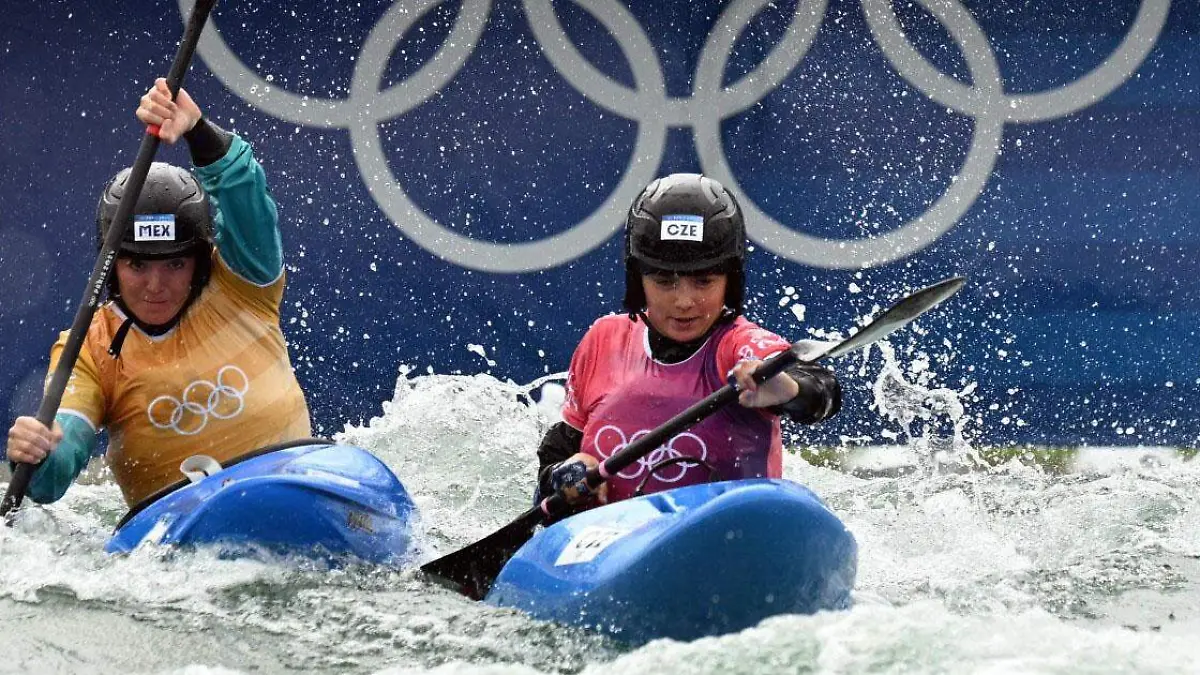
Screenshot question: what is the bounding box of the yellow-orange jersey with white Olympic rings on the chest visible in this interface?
[50,250,312,506]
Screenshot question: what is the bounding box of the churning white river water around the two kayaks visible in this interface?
[0,353,1200,675]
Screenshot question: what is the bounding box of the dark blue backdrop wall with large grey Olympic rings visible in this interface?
[0,0,1200,446]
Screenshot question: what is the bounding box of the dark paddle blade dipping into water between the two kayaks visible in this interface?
[421,507,545,601]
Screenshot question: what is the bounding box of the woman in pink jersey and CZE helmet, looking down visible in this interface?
[538,173,841,503]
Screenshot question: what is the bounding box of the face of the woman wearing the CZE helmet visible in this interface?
[642,273,728,342]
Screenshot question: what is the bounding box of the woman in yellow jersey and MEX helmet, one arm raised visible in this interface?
[6,79,311,504]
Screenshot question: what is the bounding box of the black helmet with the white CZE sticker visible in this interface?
[624,173,746,315]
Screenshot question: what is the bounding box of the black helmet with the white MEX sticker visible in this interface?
[96,162,212,295]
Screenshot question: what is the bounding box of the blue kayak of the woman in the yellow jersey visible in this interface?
[104,440,416,563]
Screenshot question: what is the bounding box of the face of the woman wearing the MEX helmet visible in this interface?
[116,256,196,325]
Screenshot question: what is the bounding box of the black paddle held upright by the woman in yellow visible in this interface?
[0,0,217,522]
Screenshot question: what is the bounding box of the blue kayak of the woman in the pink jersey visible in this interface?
[485,479,858,644]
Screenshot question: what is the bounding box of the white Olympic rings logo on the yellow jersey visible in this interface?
[146,365,250,436]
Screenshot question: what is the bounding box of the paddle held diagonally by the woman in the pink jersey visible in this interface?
[421,270,965,599]
